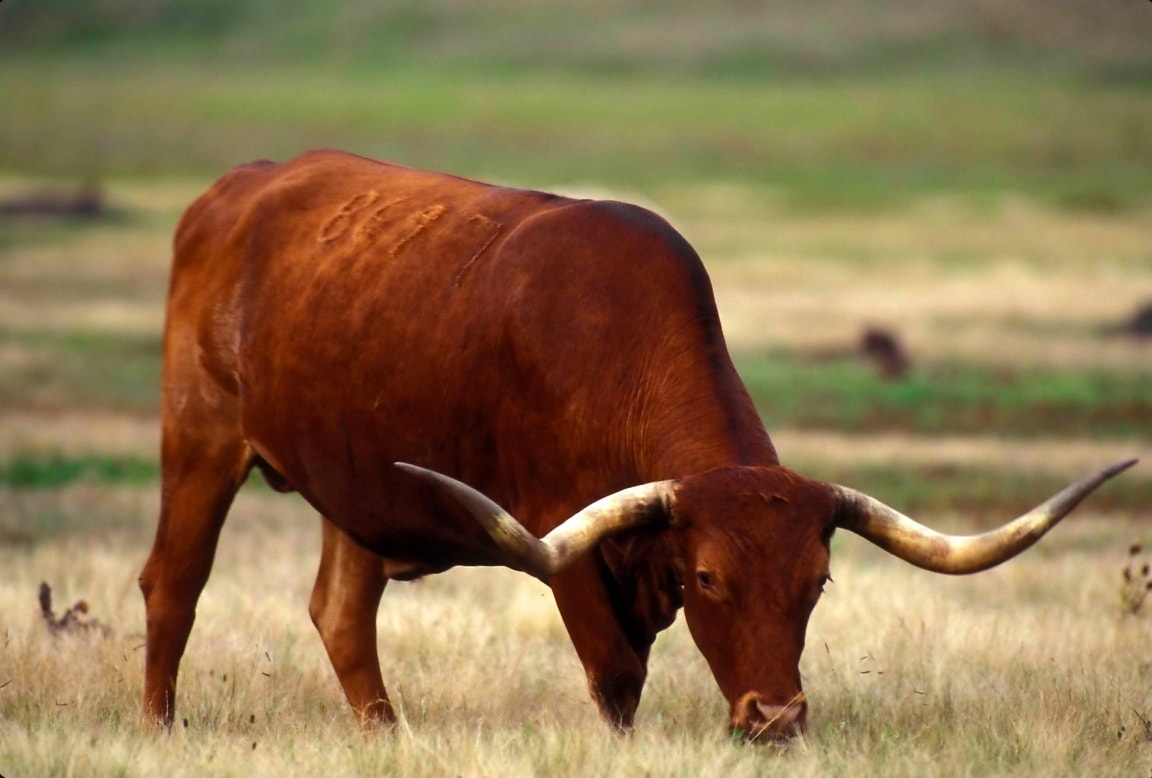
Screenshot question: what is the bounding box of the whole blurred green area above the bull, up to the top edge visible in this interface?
[0,0,1152,200]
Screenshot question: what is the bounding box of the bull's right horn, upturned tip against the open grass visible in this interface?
[829,459,1137,575]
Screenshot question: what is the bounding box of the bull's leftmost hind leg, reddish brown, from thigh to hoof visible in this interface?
[139,395,251,726]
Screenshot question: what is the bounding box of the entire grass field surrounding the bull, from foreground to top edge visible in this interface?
[0,0,1152,778]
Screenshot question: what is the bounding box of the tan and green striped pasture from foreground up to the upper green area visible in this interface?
[0,179,1152,777]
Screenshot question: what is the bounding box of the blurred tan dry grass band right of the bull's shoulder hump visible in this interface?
[673,198,1152,369]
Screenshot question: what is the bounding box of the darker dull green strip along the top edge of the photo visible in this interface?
[0,0,1152,80]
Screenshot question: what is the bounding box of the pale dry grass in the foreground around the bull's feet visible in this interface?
[0,493,1152,776]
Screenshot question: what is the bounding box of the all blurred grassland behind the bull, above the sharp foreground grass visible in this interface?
[0,0,1152,520]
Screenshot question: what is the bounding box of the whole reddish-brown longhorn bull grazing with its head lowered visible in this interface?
[141,152,1130,738]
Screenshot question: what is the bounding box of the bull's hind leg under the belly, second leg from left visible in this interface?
[309,519,395,730]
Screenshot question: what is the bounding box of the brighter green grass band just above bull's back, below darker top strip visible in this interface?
[0,60,1152,210]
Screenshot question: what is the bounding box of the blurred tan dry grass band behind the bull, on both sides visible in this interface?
[9,180,1152,361]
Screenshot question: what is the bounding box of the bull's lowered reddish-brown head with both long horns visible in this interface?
[397,460,1136,740]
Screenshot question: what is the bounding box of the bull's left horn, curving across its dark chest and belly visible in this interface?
[395,462,676,582]
